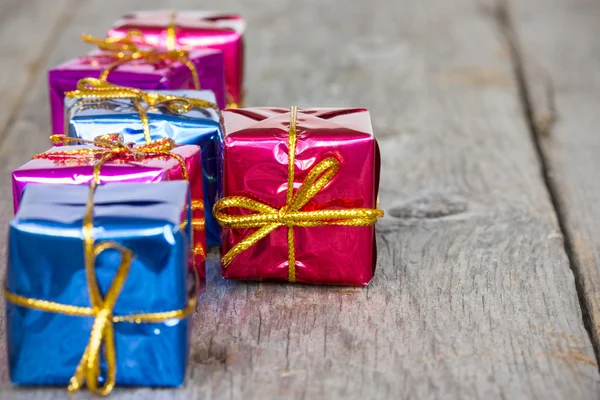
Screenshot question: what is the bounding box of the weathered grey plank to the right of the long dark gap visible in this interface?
[510,0,600,360]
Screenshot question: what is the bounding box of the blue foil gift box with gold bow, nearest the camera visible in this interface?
[5,181,197,394]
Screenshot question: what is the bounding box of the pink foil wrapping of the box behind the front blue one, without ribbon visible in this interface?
[12,146,206,277]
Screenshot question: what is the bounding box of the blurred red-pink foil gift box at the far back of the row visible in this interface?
[108,11,246,104]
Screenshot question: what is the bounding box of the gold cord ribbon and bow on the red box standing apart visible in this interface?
[213,107,383,282]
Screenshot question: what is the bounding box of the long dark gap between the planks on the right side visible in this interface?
[492,0,600,370]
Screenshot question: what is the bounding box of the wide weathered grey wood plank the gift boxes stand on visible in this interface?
[0,0,600,399]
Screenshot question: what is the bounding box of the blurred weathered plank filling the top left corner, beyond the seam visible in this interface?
[0,0,69,140]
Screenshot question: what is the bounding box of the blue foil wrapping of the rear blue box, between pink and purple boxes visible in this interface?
[65,90,223,246]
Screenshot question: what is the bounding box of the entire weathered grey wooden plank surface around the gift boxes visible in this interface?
[0,0,600,400]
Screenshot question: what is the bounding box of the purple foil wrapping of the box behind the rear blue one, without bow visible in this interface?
[48,49,226,134]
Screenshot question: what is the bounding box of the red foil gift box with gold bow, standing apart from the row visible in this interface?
[214,108,383,286]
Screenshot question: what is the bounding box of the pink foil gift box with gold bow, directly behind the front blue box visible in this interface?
[12,135,206,277]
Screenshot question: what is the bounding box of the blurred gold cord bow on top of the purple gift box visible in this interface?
[81,31,200,90]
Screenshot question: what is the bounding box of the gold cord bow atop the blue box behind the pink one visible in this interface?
[65,78,221,143]
